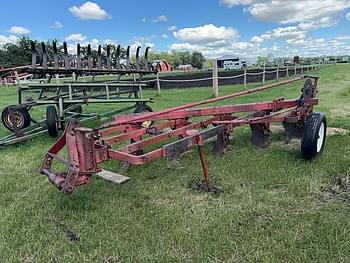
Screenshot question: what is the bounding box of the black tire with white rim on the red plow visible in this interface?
[301,112,327,160]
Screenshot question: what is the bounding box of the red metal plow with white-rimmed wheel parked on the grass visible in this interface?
[40,77,326,195]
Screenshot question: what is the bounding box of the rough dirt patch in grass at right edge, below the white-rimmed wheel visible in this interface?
[321,172,350,204]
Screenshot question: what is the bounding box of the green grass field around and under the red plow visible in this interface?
[0,65,350,262]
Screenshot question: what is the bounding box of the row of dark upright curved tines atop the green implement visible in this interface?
[28,41,156,80]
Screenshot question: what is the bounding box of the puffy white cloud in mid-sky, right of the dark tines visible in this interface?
[173,24,239,44]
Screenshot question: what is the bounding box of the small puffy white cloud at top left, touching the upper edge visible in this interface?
[68,1,111,20]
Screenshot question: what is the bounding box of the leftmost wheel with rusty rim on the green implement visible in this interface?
[1,106,31,131]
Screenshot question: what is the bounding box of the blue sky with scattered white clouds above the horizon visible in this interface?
[0,0,350,57]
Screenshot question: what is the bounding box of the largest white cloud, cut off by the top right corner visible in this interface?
[221,0,350,24]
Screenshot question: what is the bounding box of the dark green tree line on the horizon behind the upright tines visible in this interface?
[0,37,206,69]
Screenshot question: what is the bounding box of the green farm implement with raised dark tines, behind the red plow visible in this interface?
[0,42,156,146]
